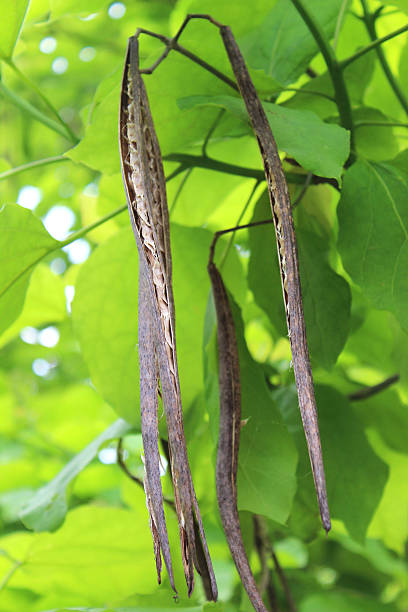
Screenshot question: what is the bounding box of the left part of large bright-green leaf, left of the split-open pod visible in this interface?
[72,227,140,425]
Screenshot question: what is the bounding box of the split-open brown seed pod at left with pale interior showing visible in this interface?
[119,35,217,600]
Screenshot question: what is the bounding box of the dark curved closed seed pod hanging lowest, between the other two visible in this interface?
[208,234,267,612]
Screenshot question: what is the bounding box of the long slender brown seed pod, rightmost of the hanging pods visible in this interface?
[216,24,331,532]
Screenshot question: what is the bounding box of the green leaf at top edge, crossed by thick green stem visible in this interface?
[239,0,348,85]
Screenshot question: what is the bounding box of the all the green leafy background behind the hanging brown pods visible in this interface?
[0,0,408,612]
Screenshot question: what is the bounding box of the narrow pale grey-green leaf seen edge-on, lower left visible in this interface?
[20,419,131,531]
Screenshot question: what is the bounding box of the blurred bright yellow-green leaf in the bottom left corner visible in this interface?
[8,504,157,606]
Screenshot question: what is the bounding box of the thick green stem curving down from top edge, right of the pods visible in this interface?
[292,0,354,152]
